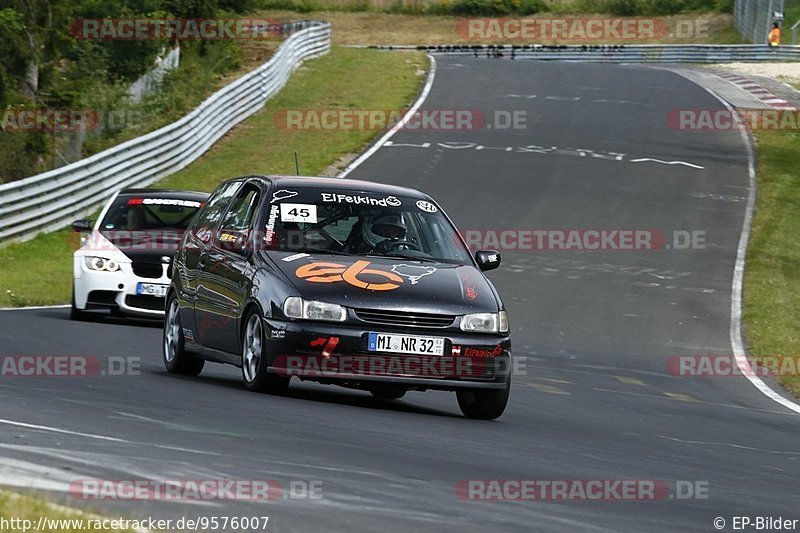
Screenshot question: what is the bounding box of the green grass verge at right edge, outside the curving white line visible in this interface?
[744,131,800,396]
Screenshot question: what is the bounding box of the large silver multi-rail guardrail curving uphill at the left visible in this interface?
[0,21,331,244]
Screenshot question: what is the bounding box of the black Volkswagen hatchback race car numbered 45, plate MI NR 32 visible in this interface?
[162,176,511,419]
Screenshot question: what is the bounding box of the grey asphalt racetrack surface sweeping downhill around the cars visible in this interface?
[0,57,800,532]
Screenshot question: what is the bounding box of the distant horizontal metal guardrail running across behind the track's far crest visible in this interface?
[367,44,800,63]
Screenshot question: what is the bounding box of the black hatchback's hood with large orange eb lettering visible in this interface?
[268,251,498,314]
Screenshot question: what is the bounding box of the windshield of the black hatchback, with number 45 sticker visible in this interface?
[264,190,471,264]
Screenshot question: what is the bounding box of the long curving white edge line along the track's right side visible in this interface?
[704,87,800,413]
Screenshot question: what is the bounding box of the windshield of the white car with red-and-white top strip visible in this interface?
[100,196,202,233]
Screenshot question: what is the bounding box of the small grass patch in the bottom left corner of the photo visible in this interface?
[0,491,133,533]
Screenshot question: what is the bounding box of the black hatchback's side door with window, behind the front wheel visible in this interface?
[196,182,264,353]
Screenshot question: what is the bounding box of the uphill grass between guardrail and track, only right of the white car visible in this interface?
[159,48,427,190]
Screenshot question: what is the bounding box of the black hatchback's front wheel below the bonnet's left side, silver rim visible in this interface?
[242,307,291,394]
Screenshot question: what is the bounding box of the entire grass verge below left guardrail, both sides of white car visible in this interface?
[0,47,427,307]
